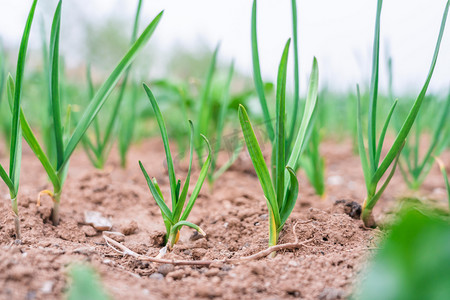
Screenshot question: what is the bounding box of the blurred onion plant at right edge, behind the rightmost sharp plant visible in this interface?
[399,94,450,190]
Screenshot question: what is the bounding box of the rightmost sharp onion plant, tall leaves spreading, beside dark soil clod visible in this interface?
[357,0,450,227]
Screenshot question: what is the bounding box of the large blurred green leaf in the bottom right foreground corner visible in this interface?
[356,209,450,300]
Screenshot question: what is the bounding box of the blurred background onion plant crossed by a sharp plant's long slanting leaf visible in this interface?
[81,0,142,169]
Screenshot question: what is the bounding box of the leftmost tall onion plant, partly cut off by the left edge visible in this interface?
[0,0,37,240]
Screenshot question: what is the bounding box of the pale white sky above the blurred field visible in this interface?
[0,0,450,94]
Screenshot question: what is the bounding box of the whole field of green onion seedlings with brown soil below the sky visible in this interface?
[0,0,450,300]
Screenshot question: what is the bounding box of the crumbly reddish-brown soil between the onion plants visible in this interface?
[0,139,450,299]
